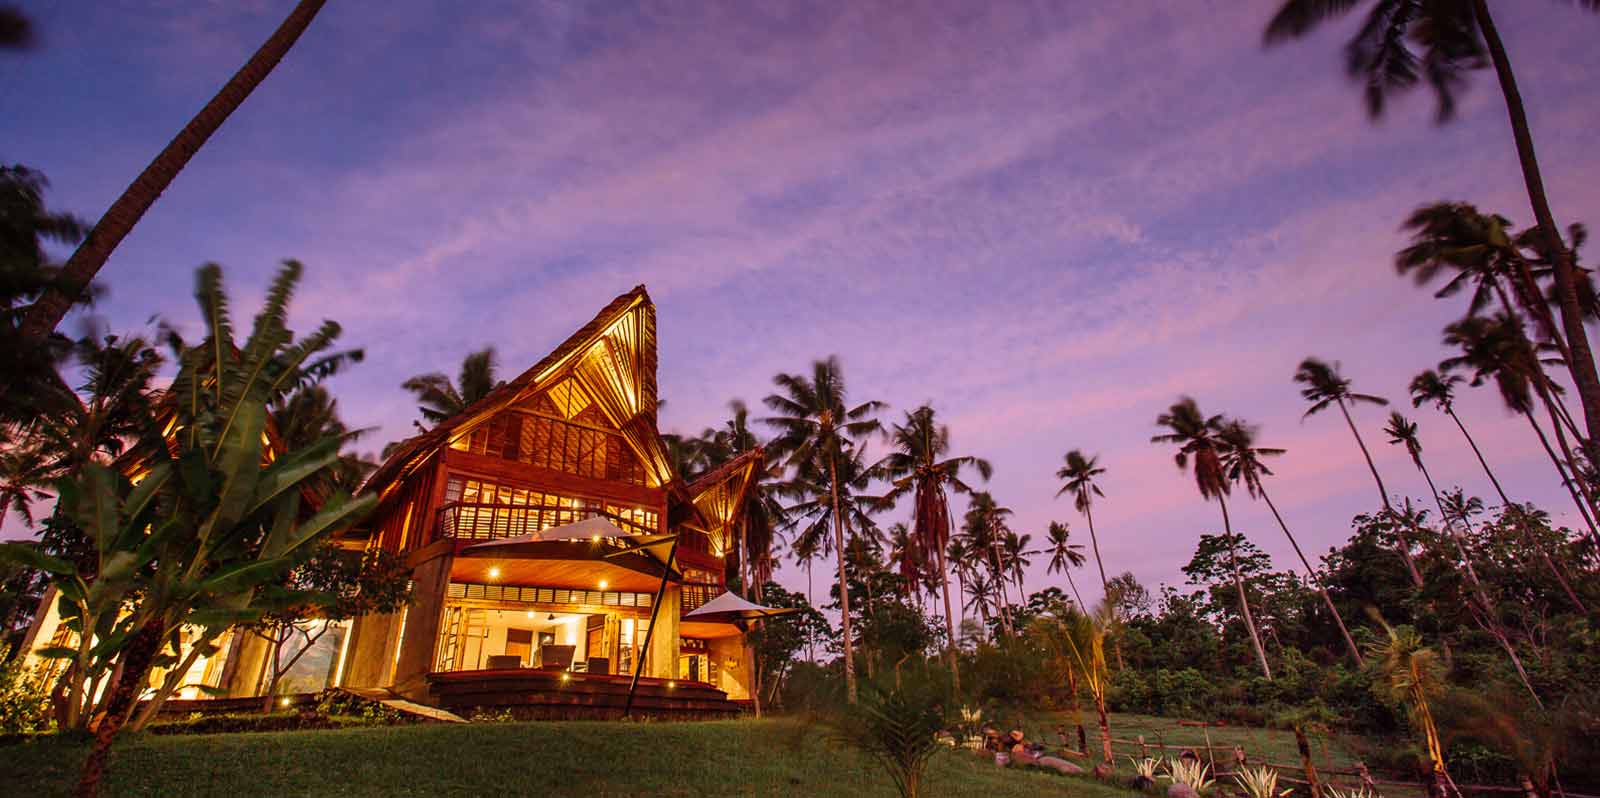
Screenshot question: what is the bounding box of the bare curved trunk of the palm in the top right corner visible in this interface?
[1472,0,1600,440]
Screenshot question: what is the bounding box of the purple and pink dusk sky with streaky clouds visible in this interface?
[0,0,1600,604]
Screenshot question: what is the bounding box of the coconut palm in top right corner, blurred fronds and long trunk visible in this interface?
[1266,0,1600,440]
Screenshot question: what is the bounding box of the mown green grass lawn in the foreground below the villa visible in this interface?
[0,720,1133,798]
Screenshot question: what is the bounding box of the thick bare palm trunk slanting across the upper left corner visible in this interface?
[22,0,326,342]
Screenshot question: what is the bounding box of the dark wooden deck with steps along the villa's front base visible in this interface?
[427,668,742,720]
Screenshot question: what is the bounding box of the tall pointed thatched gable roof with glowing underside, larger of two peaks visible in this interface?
[362,285,678,496]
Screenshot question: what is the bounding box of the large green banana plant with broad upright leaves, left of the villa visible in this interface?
[0,261,376,795]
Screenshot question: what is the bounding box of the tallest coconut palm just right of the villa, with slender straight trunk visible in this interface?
[763,355,883,704]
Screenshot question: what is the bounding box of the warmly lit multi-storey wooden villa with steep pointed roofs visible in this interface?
[18,286,762,716]
